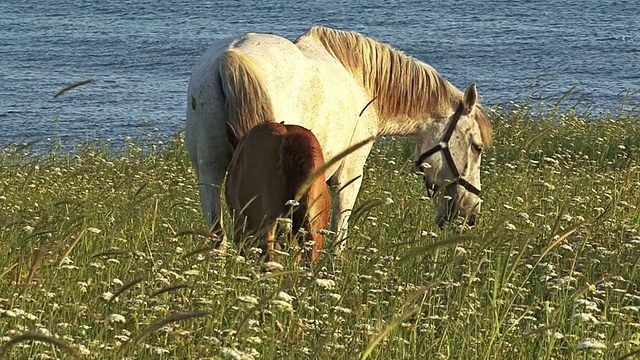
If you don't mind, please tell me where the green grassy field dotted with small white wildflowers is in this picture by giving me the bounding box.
[0,106,640,359]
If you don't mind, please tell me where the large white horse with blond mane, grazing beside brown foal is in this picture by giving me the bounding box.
[186,26,492,243]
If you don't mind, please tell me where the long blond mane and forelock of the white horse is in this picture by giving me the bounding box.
[303,26,491,145]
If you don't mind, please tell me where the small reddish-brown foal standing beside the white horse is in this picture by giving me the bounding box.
[226,122,330,260]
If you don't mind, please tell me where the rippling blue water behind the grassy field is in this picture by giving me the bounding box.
[0,0,640,146]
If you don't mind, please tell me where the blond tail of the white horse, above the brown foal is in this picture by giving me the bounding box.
[218,49,275,138]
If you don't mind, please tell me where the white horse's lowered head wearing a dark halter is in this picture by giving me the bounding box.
[416,84,491,226]
